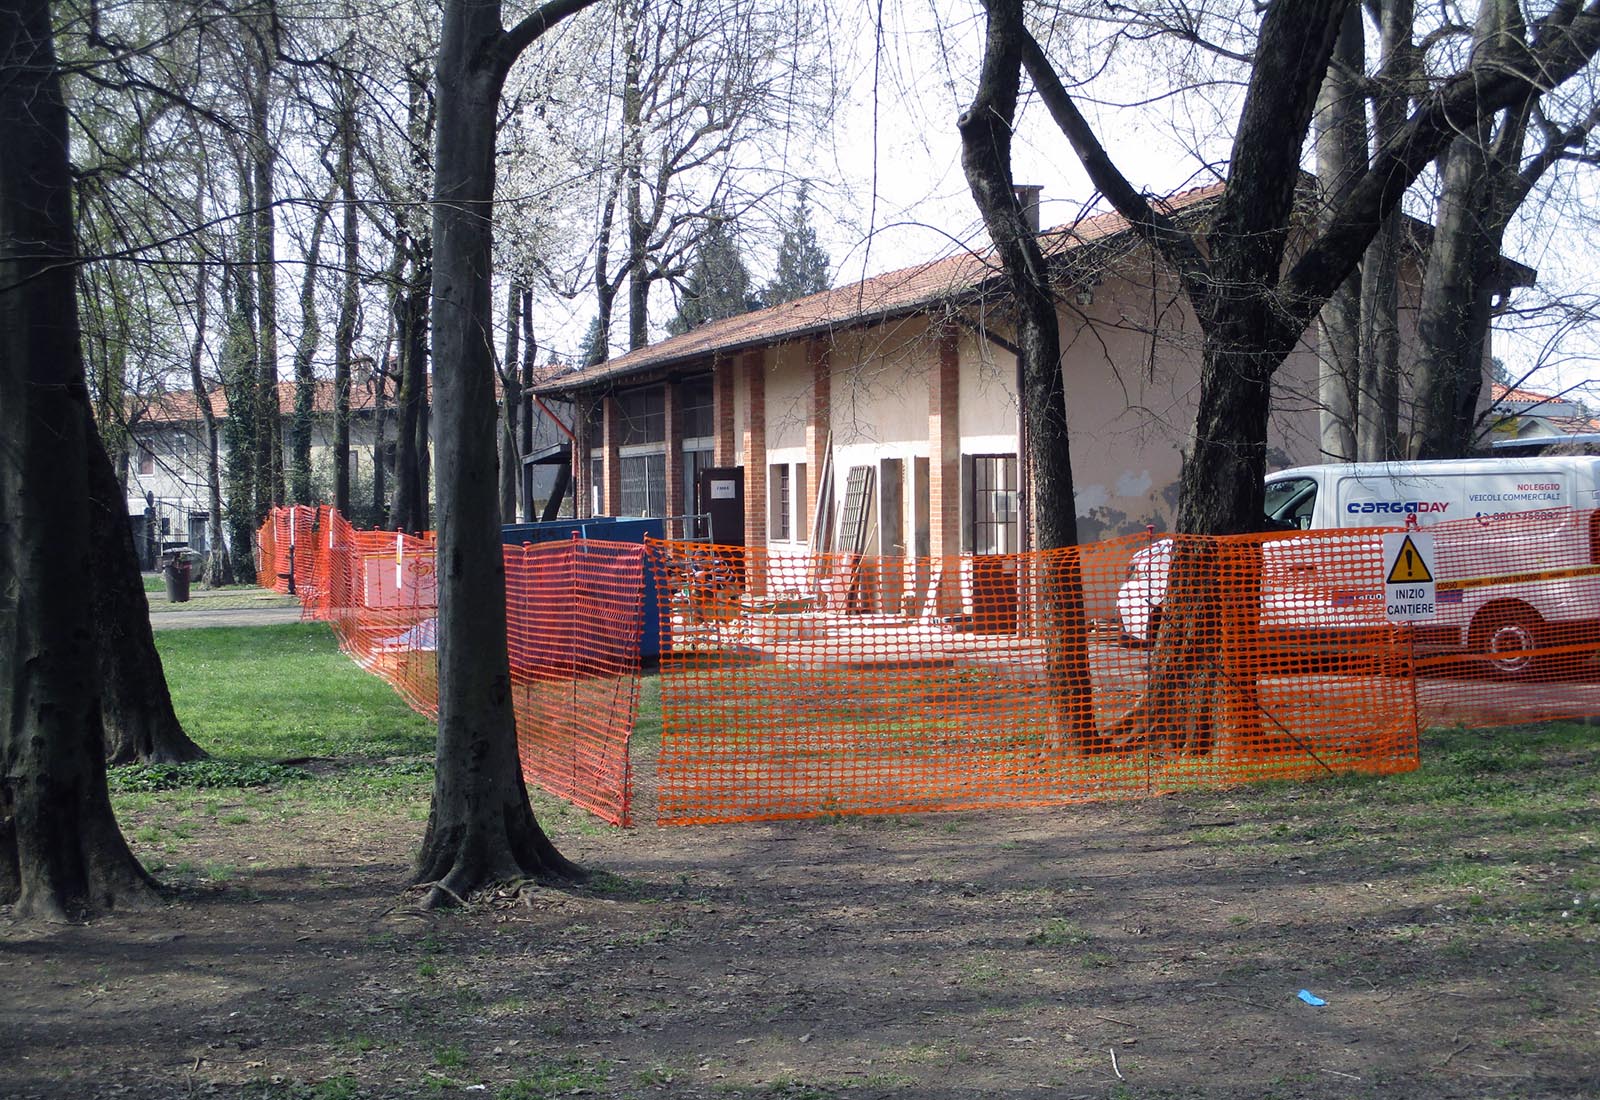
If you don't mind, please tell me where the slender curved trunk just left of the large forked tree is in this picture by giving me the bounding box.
[958,0,1098,751]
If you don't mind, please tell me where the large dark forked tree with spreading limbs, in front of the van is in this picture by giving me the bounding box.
[953,0,1600,751]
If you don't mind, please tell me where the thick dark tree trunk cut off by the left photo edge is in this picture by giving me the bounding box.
[0,0,157,919]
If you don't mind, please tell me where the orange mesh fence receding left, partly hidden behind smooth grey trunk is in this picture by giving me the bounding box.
[258,507,643,825]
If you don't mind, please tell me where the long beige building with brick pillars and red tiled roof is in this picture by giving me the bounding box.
[536,187,1531,575]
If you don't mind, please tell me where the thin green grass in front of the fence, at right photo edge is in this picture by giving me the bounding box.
[1186,721,1600,956]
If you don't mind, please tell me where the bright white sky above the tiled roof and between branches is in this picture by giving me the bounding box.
[508,0,1600,406]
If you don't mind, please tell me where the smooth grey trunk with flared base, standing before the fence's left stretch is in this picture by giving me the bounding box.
[416,0,601,905]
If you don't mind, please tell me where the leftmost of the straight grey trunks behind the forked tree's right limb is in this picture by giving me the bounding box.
[1317,3,1366,462]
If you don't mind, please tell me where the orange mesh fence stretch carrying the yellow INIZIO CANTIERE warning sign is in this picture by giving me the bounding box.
[651,512,1600,823]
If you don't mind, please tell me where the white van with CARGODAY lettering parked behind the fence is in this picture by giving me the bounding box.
[1117,456,1600,675]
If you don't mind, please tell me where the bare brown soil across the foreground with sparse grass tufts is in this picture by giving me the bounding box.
[0,773,1600,1100]
